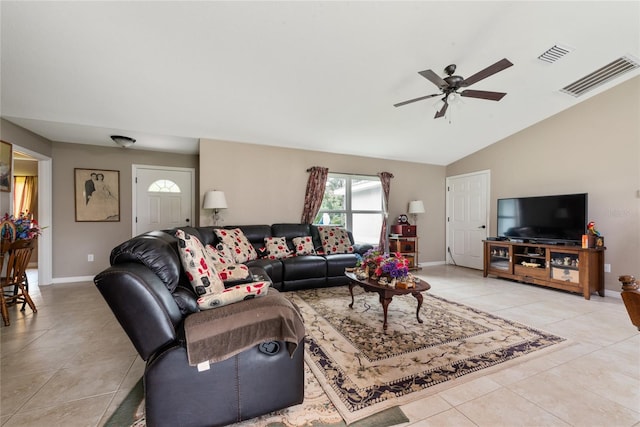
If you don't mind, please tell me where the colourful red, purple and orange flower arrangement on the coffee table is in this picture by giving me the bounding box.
[356,247,413,286]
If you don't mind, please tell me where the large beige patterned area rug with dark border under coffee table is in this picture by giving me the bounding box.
[285,287,565,424]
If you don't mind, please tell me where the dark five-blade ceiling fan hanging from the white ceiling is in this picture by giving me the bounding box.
[393,58,513,119]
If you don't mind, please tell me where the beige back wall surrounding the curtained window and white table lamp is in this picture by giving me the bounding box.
[200,139,445,263]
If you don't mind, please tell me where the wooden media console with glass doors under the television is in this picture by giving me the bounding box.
[483,240,605,299]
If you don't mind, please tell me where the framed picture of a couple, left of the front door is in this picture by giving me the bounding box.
[74,168,120,222]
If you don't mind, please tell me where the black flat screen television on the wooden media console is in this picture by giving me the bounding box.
[498,193,588,244]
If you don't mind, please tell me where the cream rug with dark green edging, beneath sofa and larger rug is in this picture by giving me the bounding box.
[112,363,409,427]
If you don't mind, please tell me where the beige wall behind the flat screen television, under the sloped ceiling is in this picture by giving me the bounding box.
[447,77,640,290]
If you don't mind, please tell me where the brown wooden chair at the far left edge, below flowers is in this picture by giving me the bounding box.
[0,222,38,326]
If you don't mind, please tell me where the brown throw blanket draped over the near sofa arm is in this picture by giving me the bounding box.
[184,288,305,366]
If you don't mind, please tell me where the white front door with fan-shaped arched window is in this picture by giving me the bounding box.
[133,165,195,236]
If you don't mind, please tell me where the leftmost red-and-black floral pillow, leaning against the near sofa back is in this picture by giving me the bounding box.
[176,230,224,296]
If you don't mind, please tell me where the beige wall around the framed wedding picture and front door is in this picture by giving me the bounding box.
[51,142,198,279]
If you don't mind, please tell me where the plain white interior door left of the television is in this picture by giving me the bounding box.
[445,171,490,269]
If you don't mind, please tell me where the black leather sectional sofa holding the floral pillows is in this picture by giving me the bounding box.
[94,224,370,427]
